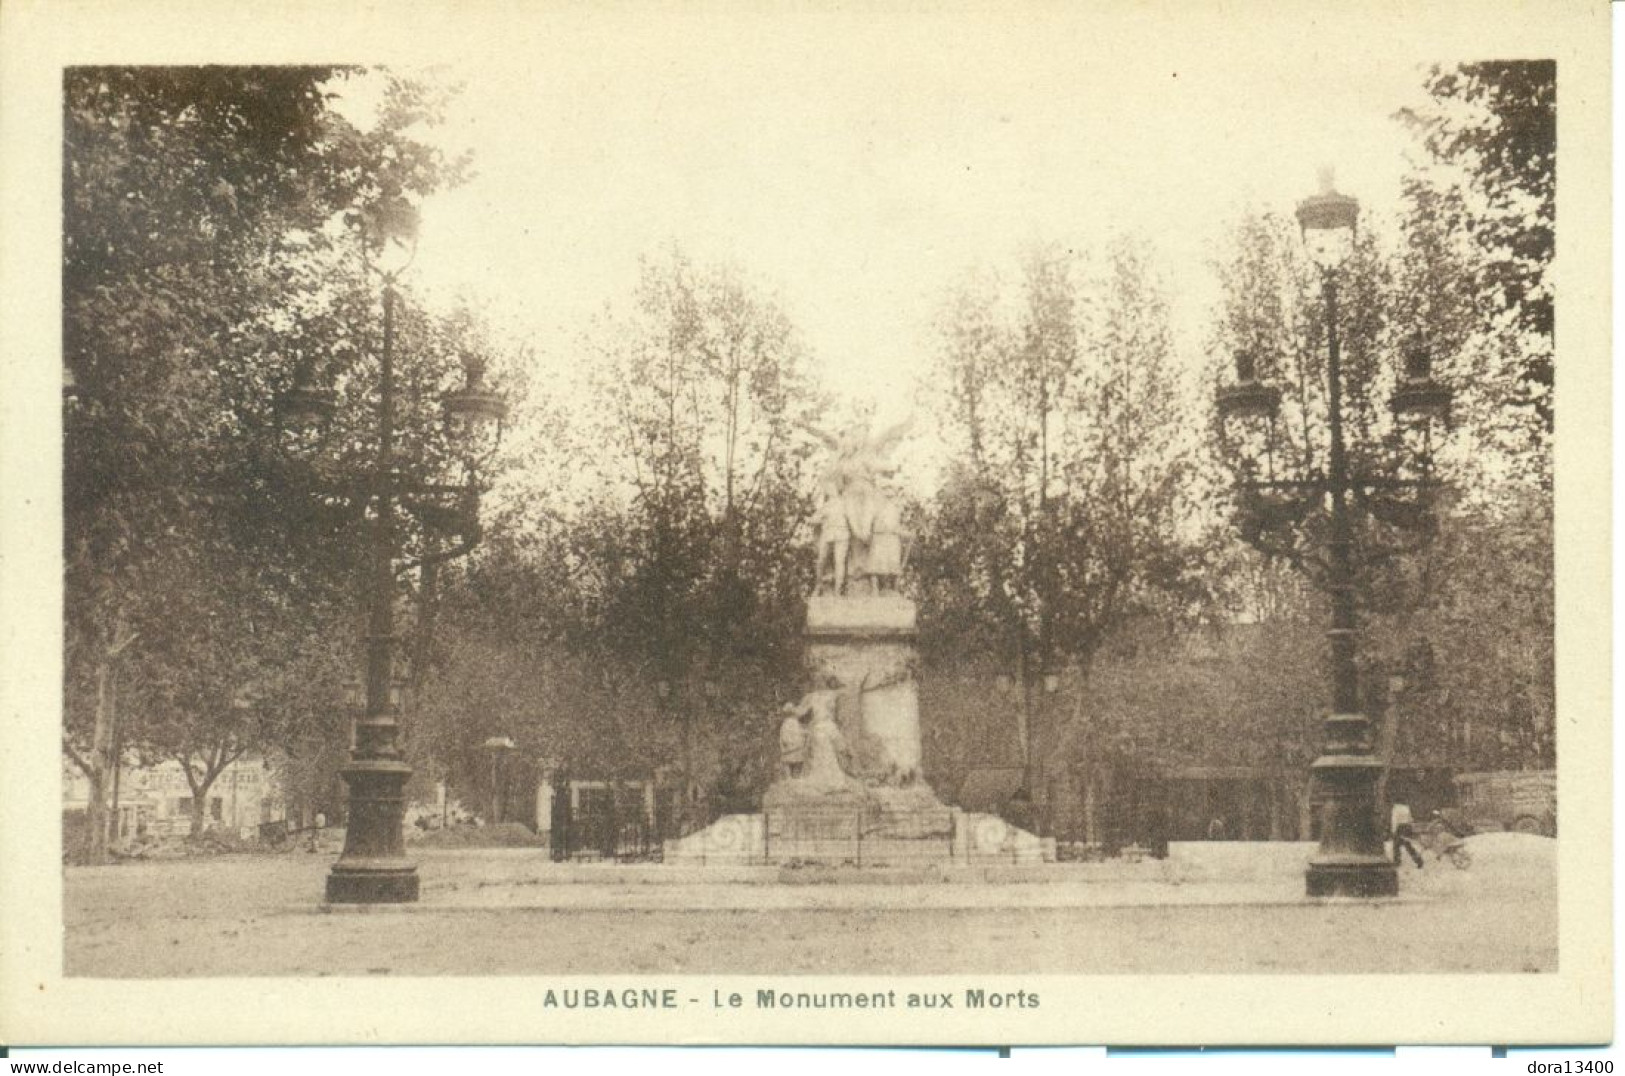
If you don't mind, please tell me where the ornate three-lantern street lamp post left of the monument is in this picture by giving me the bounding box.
[283,229,507,904]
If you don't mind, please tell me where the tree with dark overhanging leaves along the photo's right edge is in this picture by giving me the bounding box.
[1389,60,1558,767]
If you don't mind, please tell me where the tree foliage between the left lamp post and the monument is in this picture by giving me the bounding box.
[406,254,817,809]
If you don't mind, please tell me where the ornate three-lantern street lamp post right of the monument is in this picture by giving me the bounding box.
[1217,172,1450,897]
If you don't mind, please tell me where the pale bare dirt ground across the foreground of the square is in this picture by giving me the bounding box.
[63,834,1557,978]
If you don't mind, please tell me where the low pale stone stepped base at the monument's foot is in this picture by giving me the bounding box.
[663,788,1055,868]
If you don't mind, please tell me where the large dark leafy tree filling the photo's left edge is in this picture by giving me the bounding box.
[63,67,474,857]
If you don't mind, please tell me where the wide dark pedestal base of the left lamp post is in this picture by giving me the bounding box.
[327,759,418,904]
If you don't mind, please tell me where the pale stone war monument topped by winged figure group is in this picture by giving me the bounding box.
[665,421,1055,866]
